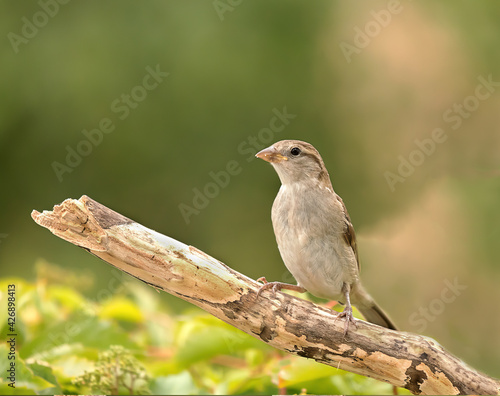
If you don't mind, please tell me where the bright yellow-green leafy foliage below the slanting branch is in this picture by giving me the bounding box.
[0,266,408,395]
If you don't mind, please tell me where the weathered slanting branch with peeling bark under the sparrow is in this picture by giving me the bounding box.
[32,195,500,395]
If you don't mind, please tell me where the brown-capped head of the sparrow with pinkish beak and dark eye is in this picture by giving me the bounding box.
[255,140,331,187]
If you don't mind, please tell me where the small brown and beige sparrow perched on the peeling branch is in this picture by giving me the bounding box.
[256,140,396,336]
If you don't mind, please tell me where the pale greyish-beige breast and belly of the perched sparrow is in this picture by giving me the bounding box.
[272,186,357,299]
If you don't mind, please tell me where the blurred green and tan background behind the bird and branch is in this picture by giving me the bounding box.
[0,0,500,377]
